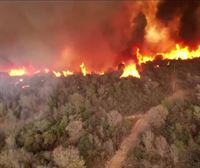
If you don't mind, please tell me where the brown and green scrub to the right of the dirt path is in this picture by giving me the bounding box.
[124,82,200,168]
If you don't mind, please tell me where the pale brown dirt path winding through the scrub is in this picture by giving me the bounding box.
[105,90,187,168]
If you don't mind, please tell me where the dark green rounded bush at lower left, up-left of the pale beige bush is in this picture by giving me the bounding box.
[15,120,59,153]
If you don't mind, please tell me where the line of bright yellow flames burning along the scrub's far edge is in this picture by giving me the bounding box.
[3,44,200,78]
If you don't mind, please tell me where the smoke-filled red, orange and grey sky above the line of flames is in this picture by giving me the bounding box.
[0,0,200,69]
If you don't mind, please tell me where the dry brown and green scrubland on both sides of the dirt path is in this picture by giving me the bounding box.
[0,59,200,168]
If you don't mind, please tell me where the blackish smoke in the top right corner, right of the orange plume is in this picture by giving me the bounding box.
[156,0,200,45]
